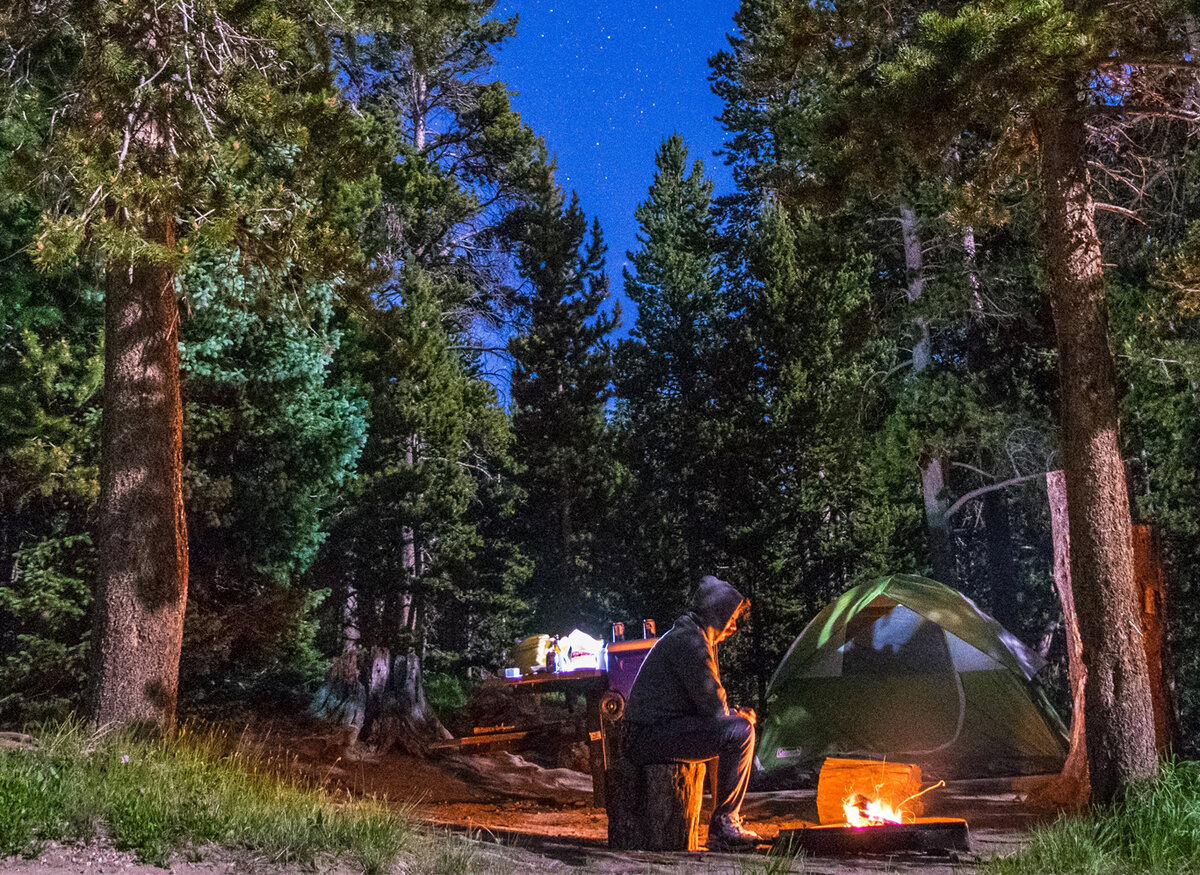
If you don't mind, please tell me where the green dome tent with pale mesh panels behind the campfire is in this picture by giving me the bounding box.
[757,574,1068,778]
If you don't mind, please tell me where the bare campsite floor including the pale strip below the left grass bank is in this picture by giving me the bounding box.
[0,721,1055,875]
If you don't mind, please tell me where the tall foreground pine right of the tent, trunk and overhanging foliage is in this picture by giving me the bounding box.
[715,0,1193,802]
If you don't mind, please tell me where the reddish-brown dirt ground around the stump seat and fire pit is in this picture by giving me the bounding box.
[274,715,1056,875]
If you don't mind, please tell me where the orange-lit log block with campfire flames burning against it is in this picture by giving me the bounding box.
[817,756,924,826]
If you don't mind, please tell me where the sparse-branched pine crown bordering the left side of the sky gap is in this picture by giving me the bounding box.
[338,0,545,321]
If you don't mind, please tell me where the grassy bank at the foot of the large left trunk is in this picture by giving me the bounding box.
[0,724,413,875]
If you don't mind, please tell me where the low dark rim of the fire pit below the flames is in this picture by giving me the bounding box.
[775,817,971,856]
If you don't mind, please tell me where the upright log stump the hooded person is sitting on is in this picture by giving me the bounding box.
[604,723,704,851]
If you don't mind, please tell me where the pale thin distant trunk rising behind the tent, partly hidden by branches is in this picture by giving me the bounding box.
[900,204,958,586]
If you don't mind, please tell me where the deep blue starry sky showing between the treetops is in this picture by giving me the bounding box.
[496,0,738,334]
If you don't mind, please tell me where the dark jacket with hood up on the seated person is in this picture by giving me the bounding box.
[625,576,745,724]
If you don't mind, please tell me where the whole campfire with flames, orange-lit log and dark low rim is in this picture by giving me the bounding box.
[775,757,971,855]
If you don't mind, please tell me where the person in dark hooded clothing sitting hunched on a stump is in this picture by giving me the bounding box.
[625,568,760,850]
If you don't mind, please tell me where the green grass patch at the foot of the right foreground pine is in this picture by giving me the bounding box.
[988,761,1200,875]
